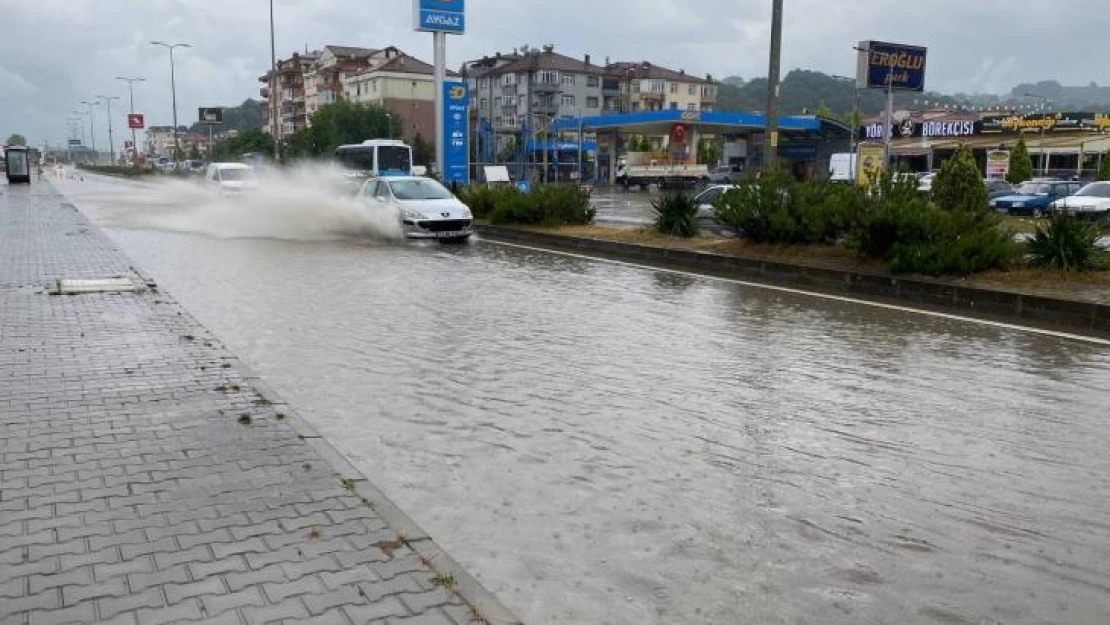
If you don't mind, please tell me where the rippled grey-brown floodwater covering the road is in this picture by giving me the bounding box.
[58,170,1110,625]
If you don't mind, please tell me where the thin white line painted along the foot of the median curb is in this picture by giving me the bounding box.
[482,238,1110,346]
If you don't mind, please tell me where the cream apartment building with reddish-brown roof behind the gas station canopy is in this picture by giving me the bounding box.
[604,61,717,113]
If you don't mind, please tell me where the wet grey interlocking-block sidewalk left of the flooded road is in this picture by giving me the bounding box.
[0,185,514,625]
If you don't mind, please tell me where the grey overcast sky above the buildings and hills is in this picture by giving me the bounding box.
[0,0,1110,148]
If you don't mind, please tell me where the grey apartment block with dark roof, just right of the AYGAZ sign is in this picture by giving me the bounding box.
[464,46,605,139]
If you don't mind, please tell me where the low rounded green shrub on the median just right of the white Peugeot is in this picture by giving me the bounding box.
[486,184,595,228]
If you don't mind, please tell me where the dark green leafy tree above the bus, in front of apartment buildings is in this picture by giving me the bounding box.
[290,100,390,158]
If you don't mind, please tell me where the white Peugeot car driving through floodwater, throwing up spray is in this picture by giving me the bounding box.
[359,175,474,242]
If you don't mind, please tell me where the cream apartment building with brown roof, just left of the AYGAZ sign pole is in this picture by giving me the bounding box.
[343,47,458,143]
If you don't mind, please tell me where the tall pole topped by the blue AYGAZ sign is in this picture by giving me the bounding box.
[413,0,470,175]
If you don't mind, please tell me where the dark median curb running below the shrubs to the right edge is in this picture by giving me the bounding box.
[475,225,1110,339]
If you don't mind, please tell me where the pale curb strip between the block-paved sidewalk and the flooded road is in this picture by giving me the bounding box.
[54,188,523,625]
